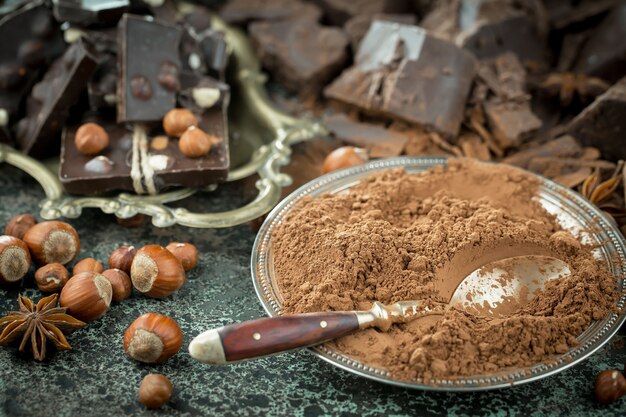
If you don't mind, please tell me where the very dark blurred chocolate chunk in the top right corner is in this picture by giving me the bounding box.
[574,2,626,83]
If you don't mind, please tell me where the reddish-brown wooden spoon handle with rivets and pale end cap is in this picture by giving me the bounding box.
[189,311,359,365]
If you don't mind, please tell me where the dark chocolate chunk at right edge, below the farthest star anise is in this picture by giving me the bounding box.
[567,77,626,160]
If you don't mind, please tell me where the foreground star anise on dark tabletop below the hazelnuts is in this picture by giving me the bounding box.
[0,294,86,361]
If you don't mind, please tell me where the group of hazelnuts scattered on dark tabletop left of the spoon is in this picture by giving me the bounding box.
[0,214,198,408]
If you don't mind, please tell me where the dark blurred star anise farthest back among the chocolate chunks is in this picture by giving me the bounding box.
[541,72,609,106]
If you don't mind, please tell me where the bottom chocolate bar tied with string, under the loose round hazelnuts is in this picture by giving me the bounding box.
[59,73,230,195]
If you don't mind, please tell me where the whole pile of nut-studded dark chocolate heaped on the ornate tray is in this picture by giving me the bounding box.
[0,0,230,195]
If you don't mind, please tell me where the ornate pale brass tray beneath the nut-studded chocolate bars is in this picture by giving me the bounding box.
[0,17,326,228]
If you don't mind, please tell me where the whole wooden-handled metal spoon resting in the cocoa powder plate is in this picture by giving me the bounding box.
[189,256,570,365]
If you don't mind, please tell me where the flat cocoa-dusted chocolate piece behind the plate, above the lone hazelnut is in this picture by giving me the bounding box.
[324,114,408,158]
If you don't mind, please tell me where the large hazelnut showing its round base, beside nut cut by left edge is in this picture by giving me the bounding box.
[24,221,80,265]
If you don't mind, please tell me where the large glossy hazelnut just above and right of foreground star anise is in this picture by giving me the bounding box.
[59,272,113,321]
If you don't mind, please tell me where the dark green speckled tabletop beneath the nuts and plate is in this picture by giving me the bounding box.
[0,165,626,416]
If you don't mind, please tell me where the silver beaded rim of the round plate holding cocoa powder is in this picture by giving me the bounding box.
[251,157,626,391]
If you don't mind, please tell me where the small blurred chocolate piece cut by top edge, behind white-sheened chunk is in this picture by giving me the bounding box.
[315,0,410,26]
